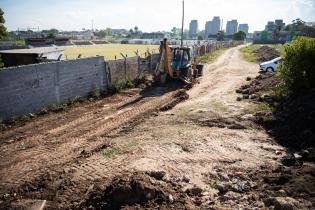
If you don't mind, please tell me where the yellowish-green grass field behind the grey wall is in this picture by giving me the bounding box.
[65,44,159,60]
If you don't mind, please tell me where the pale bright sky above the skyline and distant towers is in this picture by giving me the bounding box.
[0,0,315,32]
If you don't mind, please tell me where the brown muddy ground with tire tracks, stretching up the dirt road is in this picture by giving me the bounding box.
[0,47,314,209]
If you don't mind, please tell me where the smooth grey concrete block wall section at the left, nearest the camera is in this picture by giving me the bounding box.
[0,56,108,119]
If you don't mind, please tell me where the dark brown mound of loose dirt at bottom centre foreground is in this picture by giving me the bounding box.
[75,172,194,210]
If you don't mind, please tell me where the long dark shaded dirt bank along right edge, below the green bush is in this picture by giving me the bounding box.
[237,73,315,209]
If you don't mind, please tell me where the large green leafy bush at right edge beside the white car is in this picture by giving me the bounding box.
[278,37,315,95]
